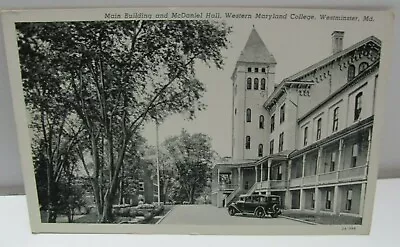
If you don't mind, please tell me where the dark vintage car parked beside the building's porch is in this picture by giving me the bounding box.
[228,195,282,218]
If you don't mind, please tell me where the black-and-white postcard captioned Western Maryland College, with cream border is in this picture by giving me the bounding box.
[1,7,394,235]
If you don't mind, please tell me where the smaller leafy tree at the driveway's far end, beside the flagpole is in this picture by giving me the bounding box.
[163,130,216,203]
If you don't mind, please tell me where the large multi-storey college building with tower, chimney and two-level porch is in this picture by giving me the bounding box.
[212,29,381,217]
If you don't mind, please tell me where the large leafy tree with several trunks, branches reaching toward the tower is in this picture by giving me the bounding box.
[17,20,230,222]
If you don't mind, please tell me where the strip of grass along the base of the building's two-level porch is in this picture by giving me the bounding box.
[283,211,362,225]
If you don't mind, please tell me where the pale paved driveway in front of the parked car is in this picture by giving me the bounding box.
[160,205,304,225]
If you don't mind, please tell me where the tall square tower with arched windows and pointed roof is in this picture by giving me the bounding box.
[231,27,276,160]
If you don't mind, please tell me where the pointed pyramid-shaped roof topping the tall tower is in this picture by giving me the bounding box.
[238,27,276,63]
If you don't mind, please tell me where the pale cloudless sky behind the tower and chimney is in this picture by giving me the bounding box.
[143,14,384,157]
